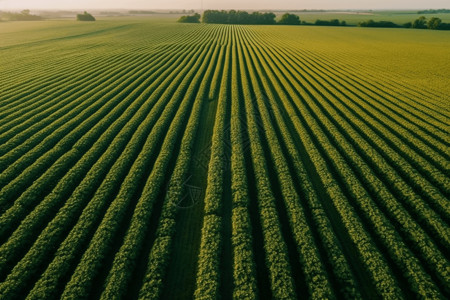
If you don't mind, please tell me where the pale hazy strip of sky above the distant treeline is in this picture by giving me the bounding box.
[0,0,450,10]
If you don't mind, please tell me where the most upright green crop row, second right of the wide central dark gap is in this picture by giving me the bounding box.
[230,41,258,299]
